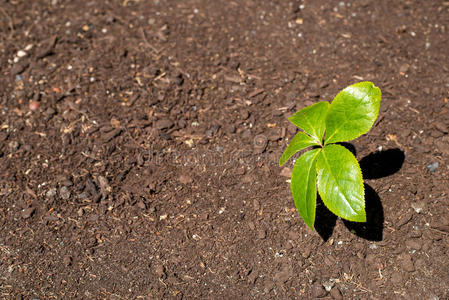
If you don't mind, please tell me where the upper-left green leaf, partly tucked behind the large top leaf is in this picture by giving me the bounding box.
[289,101,329,145]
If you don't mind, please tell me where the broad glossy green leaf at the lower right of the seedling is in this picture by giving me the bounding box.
[316,145,366,222]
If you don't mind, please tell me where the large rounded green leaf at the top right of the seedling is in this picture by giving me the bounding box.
[325,81,381,145]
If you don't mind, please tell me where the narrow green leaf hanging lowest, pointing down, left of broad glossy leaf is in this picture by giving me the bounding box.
[290,149,321,230]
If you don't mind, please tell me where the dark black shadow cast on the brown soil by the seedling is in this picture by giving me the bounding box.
[315,148,405,241]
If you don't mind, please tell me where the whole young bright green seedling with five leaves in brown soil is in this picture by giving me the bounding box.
[279,82,381,230]
